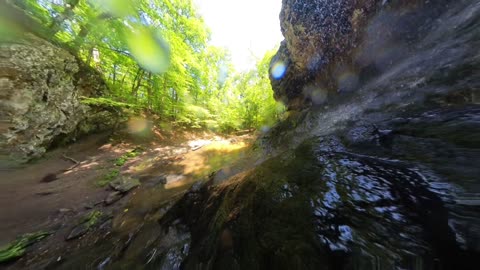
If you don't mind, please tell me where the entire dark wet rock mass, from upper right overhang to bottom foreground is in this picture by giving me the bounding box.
[148,1,480,269]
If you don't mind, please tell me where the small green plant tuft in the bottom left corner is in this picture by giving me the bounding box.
[0,231,51,263]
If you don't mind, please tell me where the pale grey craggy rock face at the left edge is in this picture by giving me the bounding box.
[0,34,106,161]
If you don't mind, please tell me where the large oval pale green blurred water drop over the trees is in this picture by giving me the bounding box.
[127,29,170,74]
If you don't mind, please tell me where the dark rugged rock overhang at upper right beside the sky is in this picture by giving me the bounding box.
[270,0,448,109]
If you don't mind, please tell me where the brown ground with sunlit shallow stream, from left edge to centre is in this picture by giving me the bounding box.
[0,127,254,268]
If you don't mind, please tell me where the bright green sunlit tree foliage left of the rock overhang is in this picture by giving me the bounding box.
[4,0,285,132]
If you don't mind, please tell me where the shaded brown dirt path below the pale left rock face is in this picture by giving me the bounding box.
[0,135,114,246]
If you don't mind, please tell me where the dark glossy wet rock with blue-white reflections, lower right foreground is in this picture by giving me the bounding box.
[156,133,480,269]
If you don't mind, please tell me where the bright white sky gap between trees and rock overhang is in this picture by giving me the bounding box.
[194,0,283,70]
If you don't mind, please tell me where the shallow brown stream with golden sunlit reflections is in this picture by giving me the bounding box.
[113,137,251,236]
